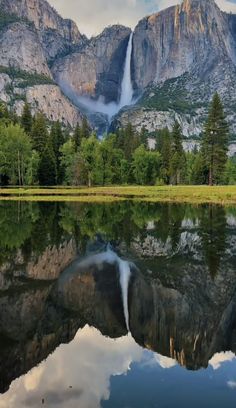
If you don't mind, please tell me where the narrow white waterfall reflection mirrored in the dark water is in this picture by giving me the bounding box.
[119,258,131,331]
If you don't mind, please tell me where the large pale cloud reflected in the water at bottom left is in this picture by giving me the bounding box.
[0,326,143,408]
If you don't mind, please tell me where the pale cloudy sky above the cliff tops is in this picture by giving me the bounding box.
[48,0,236,37]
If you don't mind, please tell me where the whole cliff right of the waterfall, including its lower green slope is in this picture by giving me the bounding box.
[115,0,236,136]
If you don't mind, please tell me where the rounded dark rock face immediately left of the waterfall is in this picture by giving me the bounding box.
[52,26,131,103]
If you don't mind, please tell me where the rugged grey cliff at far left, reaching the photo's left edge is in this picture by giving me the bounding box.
[0,0,86,126]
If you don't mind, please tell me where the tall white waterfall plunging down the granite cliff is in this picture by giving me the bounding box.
[119,32,134,109]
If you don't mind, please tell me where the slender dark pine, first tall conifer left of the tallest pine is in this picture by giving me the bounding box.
[170,121,185,185]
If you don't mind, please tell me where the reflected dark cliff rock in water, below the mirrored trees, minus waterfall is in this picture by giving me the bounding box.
[0,247,236,392]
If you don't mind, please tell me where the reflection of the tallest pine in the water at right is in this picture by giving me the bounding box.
[200,204,227,277]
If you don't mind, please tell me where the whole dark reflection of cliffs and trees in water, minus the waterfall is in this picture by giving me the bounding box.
[0,203,236,392]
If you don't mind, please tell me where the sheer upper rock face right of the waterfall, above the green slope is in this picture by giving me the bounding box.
[133,0,236,89]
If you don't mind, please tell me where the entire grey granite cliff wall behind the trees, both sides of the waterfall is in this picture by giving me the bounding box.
[0,0,236,137]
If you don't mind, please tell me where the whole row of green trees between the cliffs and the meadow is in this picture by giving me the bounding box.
[0,94,236,187]
